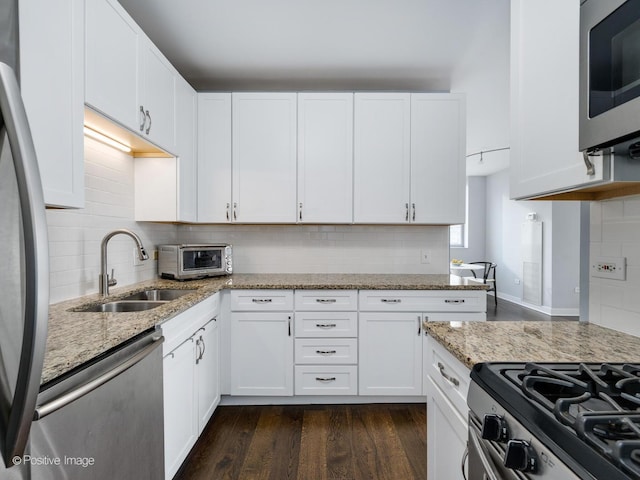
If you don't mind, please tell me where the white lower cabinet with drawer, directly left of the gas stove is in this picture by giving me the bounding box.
[424,336,470,480]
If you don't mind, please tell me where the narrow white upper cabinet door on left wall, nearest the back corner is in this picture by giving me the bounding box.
[176,78,198,222]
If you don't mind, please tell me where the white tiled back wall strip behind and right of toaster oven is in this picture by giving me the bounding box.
[178,225,449,273]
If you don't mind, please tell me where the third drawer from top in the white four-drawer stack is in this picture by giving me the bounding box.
[295,338,358,365]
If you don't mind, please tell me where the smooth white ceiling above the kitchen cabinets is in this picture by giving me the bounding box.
[120,0,509,174]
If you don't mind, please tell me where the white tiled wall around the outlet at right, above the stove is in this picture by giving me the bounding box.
[588,196,640,336]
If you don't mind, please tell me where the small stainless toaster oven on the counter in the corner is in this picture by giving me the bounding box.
[158,244,233,280]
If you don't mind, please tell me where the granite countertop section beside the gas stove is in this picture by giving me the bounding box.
[424,321,640,368]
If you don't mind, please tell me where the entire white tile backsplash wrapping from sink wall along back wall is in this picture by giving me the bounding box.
[47,139,449,303]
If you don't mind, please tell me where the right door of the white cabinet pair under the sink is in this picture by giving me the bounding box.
[195,318,220,432]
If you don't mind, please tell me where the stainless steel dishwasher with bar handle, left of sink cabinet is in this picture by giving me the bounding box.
[22,330,164,480]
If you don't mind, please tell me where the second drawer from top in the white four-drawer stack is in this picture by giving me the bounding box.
[295,312,358,338]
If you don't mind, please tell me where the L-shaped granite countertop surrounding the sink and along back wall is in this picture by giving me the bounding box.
[42,274,486,384]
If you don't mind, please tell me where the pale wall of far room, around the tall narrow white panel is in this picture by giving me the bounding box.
[486,170,580,315]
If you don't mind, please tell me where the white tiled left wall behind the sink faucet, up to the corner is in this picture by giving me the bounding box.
[47,139,176,303]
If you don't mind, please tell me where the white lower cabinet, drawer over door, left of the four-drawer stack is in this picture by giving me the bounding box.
[230,290,293,396]
